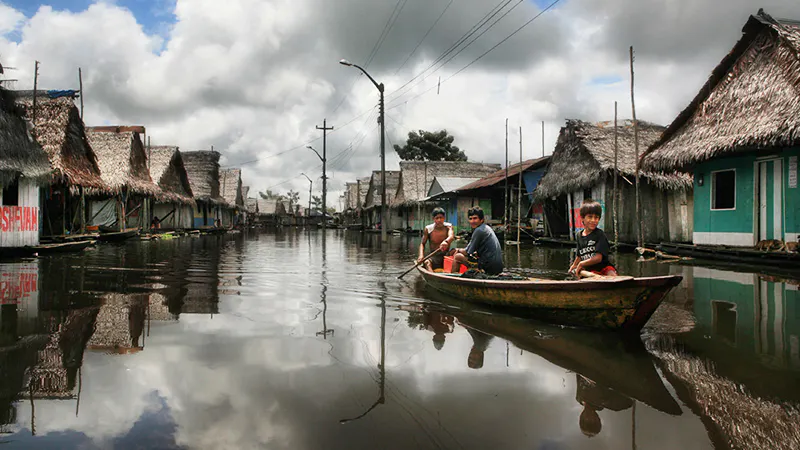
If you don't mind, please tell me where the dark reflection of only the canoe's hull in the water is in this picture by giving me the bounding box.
[442,299,682,415]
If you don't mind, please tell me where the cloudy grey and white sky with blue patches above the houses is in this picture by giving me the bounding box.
[0,0,800,208]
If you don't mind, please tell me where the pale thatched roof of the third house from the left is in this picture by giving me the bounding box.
[86,127,161,196]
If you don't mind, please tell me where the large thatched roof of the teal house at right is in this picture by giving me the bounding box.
[643,10,800,170]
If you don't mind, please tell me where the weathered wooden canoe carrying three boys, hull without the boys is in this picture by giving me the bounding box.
[417,267,683,331]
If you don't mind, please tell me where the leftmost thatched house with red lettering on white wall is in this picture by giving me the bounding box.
[0,88,52,246]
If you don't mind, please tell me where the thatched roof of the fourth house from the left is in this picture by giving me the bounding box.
[148,145,194,205]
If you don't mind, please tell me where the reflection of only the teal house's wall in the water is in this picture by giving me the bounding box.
[694,267,800,370]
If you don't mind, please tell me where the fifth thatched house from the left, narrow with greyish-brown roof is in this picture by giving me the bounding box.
[181,150,224,229]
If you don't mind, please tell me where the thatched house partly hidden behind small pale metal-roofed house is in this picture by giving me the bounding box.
[390,161,500,231]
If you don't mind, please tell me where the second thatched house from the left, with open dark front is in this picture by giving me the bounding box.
[18,91,112,237]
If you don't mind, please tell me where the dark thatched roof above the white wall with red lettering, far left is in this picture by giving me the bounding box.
[0,87,53,186]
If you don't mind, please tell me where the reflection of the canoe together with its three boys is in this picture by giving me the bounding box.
[400,282,682,436]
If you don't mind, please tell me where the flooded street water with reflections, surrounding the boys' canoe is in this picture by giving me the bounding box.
[0,229,800,450]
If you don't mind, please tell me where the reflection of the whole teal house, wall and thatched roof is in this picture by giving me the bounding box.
[645,267,800,448]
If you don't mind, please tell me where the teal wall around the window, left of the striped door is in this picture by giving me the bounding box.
[694,155,756,233]
